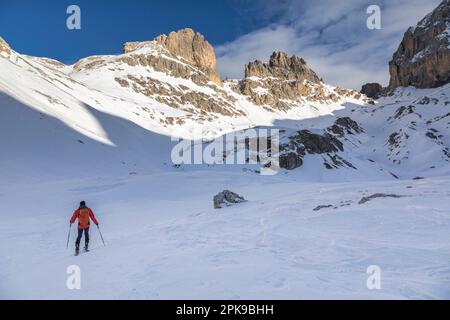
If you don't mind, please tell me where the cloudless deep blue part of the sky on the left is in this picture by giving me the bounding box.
[0,0,250,62]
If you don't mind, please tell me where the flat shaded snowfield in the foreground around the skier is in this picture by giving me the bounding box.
[0,172,450,299]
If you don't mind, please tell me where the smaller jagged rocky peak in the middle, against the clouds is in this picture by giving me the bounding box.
[245,51,320,83]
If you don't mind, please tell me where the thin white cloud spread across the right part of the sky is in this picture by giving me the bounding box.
[216,0,440,89]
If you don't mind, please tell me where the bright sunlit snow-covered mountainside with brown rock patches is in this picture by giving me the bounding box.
[0,35,370,139]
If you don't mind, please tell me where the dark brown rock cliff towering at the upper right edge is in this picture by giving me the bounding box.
[388,0,450,91]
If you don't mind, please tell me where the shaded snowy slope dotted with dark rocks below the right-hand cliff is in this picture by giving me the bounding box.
[275,85,450,179]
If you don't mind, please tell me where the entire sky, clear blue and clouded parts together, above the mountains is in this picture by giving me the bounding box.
[0,0,440,89]
